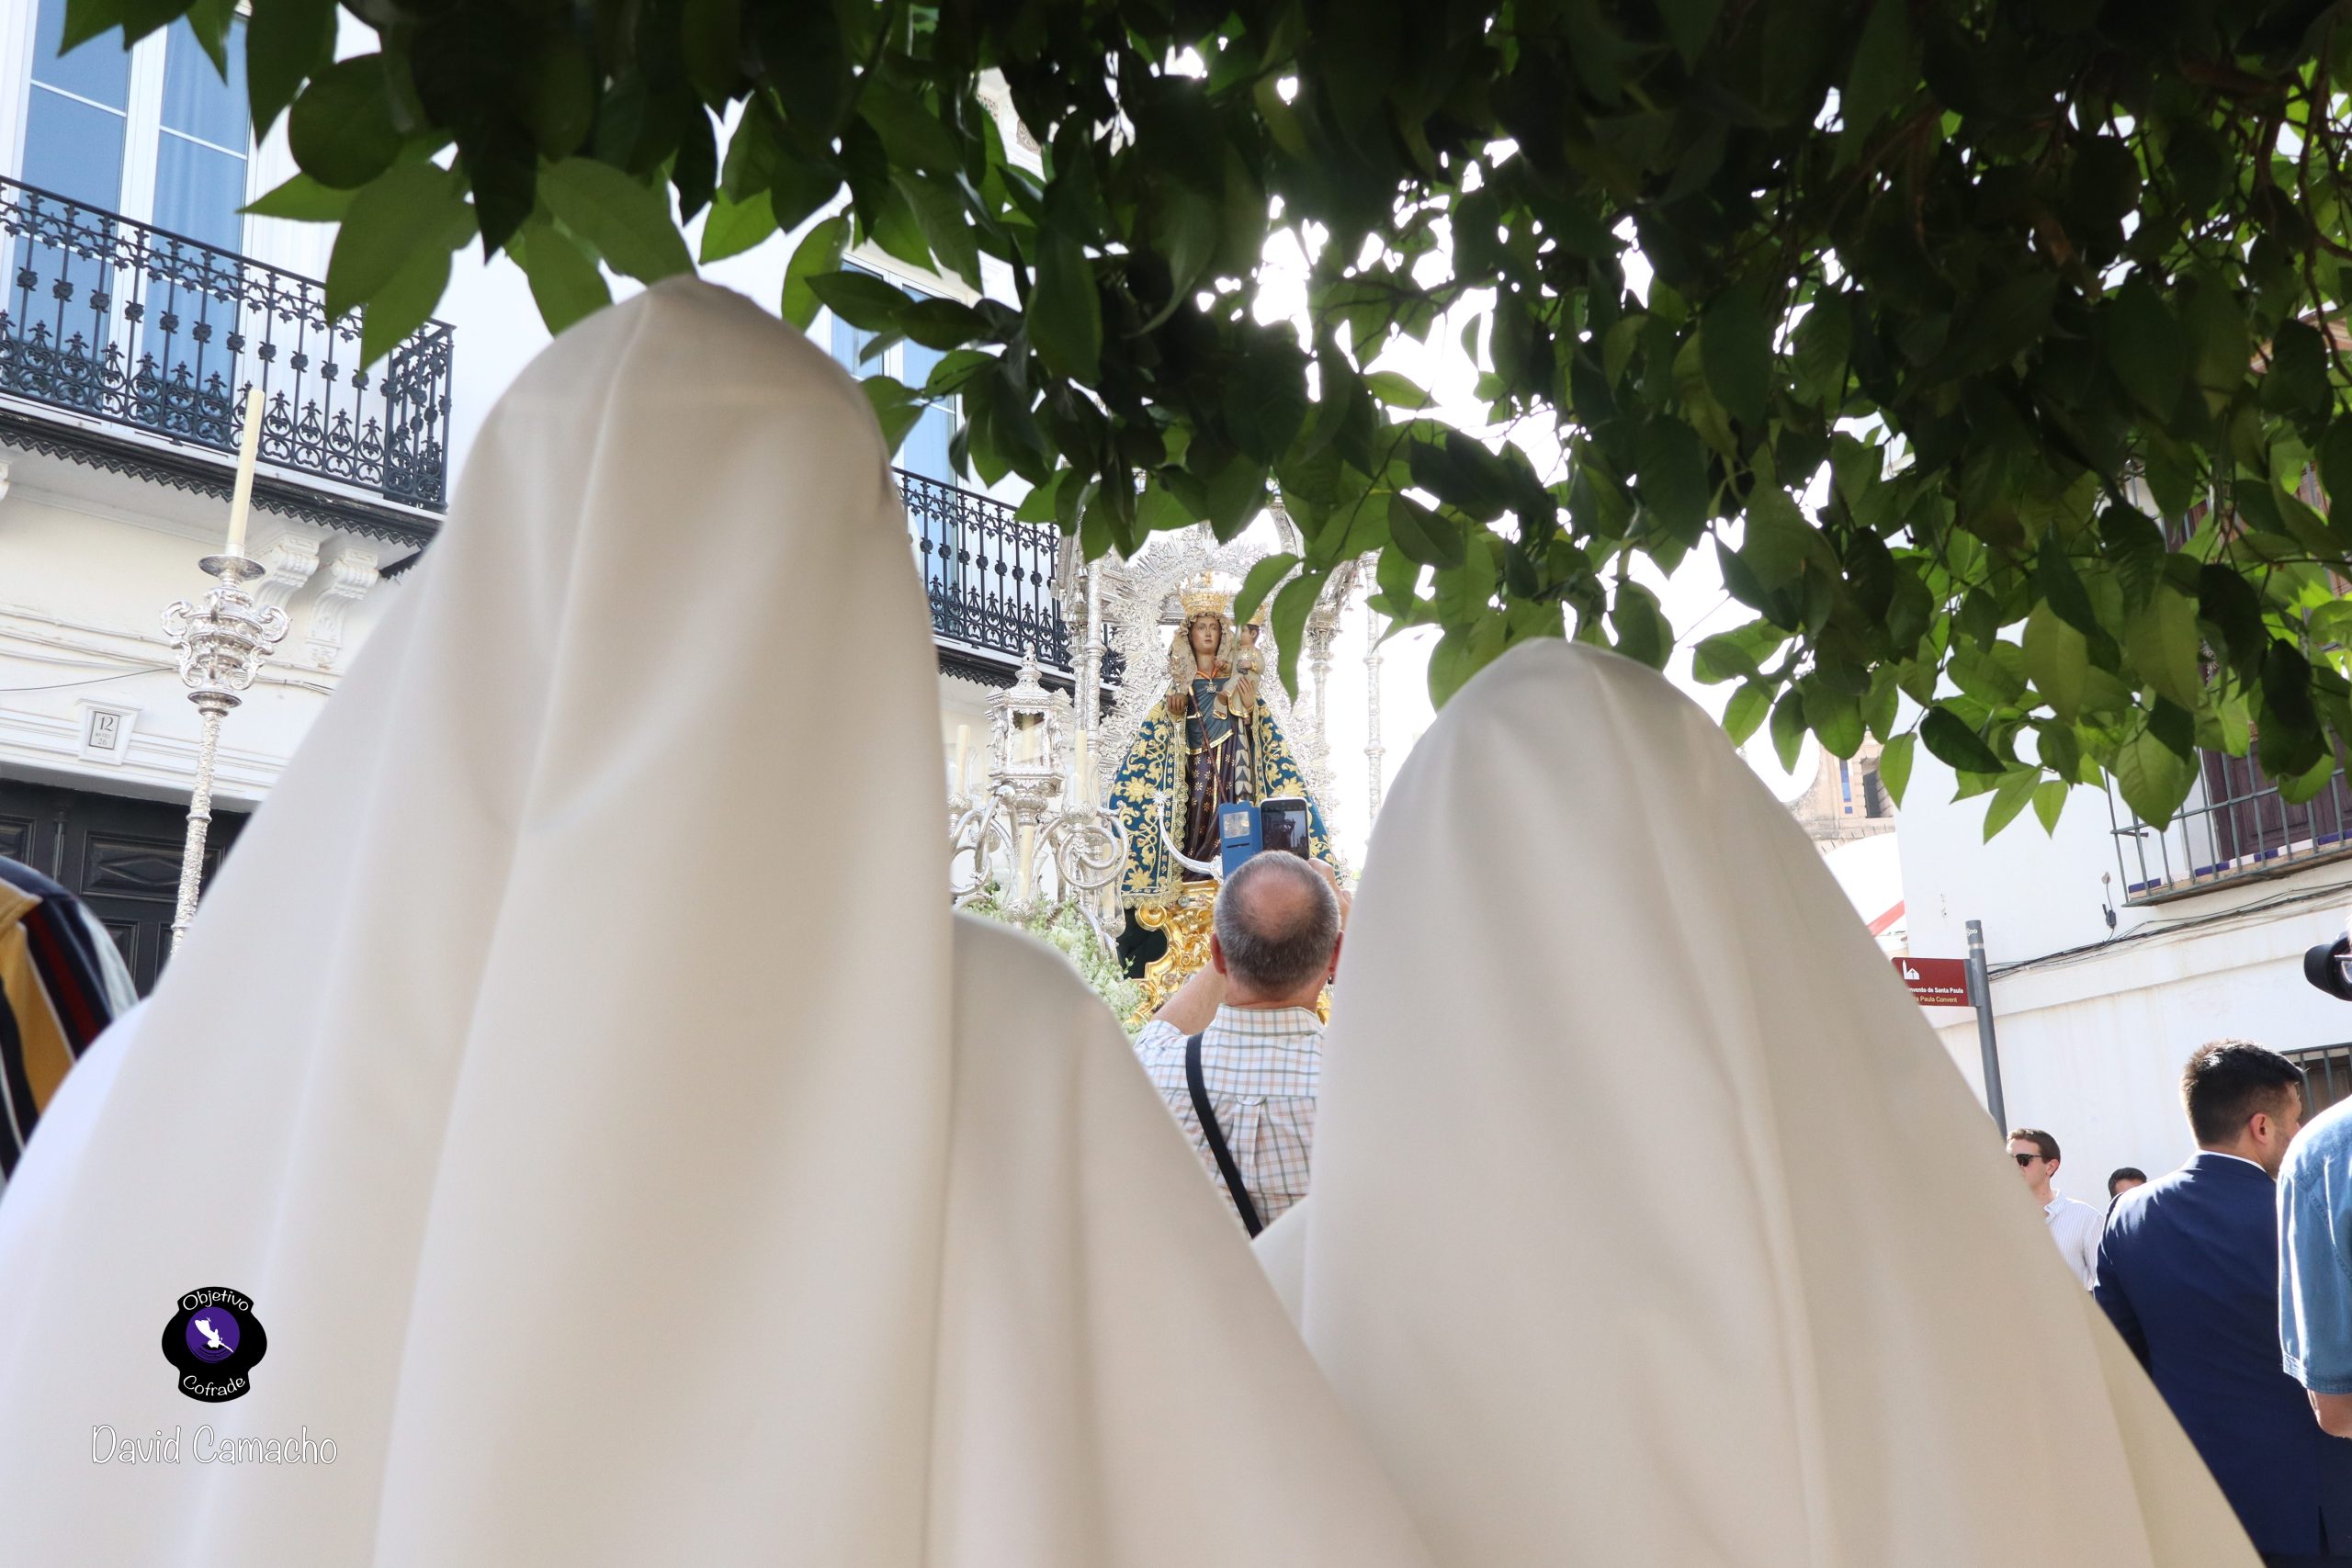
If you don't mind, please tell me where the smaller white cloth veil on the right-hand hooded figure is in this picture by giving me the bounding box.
[1261,642,2253,1568]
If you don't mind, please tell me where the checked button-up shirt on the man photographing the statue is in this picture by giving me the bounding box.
[1136,1006,1322,1224]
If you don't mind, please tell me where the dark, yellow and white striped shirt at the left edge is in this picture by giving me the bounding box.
[0,861,136,1178]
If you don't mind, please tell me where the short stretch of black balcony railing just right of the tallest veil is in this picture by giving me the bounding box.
[899,468,1070,672]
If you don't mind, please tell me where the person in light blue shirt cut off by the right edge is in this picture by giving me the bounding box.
[2279,1100,2352,1437]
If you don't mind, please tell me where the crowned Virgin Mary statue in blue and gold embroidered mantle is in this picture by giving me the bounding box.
[1110,585,1331,903]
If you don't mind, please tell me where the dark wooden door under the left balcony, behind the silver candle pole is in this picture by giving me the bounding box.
[0,778,244,997]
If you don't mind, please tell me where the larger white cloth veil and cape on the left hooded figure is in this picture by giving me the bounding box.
[0,282,1419,1568]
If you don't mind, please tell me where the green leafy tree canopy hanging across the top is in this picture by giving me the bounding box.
[68,0,2352,832]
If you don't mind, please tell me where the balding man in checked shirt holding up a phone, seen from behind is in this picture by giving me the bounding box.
[1136,853,1345,1236]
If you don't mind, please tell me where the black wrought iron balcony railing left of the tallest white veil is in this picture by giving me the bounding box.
[0,179,452,510]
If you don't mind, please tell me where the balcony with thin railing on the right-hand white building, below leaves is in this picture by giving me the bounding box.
[2108,752,2352,903]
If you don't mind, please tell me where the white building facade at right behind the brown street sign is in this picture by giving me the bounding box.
[1895,752,2352,1201]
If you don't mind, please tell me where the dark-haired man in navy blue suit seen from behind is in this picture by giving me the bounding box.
[2098,1039,2352,1568]
